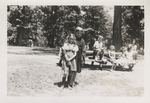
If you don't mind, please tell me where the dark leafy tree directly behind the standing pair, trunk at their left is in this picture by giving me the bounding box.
[41,6,80,47]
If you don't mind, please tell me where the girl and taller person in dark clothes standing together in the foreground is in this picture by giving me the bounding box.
[62,27,85,87]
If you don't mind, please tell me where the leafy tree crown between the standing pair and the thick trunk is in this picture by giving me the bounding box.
[82,6,112,41]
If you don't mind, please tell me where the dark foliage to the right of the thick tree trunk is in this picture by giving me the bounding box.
[122,6,144,47]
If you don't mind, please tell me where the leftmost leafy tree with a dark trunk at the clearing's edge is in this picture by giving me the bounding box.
[8,5,31,45]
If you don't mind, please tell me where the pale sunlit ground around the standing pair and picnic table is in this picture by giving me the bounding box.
[7,46,144,97]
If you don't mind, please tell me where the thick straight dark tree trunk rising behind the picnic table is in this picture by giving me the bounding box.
[113,6,122,51]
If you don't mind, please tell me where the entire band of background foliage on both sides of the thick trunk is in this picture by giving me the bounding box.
[7,5,144,47]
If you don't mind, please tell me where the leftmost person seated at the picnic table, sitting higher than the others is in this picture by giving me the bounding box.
[93,35,104,61]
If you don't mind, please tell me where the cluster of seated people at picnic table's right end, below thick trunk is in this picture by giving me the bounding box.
[108,44,137,71]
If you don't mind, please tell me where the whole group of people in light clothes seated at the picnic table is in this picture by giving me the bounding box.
[93,36,137,71]
